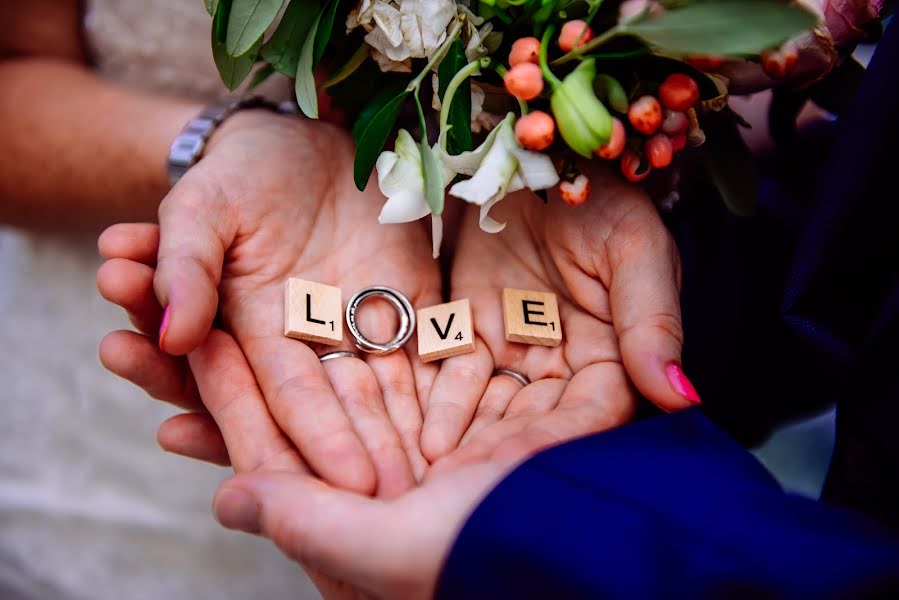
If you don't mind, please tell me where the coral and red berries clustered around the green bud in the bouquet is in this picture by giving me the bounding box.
[503,20,699,205]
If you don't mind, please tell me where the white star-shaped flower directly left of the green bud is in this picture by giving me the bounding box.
[435,113,559,233]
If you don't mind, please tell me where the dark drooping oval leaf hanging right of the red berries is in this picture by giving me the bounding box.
[701,112,759,217]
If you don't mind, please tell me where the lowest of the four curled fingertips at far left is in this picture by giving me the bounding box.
[156,413,231,467]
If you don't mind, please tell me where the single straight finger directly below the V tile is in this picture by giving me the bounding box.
[421,340,493,462]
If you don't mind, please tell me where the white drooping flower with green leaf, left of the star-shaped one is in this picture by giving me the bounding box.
[375,129,454,258]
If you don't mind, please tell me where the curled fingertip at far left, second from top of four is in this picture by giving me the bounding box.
[97,258,162,337]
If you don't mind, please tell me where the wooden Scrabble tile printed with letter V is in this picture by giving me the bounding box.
[418,299,474,362]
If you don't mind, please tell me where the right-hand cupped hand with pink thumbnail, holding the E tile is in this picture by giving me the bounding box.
[422,163,698,465]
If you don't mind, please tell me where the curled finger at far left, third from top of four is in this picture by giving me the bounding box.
[100,331,205,411]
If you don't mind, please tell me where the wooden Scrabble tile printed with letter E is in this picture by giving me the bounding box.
[503,288,562,346]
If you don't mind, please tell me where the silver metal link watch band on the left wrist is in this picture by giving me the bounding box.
[166,96,278,185]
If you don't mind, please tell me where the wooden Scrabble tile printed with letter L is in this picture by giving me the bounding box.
[284,279,343,346]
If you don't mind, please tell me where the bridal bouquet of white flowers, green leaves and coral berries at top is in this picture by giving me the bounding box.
[206,0,879,256]
